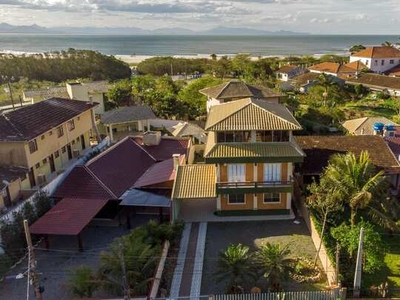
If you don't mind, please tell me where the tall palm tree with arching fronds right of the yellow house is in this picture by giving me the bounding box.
[325,151,397,229]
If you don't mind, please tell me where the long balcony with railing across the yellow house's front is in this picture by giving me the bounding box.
[217,180,293,194]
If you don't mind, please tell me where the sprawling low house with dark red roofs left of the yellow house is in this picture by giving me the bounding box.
[30,137,190,249]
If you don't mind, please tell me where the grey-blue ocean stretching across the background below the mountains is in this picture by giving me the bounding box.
[0,34,399,56]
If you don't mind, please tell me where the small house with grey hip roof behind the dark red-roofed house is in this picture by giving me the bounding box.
[101,105,156,142]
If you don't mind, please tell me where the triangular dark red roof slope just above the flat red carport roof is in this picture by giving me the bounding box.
[52,166,118,200]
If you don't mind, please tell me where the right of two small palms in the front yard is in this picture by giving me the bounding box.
[256,243,292,291]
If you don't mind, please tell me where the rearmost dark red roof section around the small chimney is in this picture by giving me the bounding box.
[131,136,190,161]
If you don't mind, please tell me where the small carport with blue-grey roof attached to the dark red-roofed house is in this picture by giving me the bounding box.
[119,188,171,228]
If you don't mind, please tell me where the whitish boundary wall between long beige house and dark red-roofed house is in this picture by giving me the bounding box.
[0,137,110,222]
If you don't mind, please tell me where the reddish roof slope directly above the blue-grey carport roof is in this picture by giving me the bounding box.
[133,155,185,188]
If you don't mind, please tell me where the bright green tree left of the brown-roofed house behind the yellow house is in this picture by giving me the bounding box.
[178,77,222,120]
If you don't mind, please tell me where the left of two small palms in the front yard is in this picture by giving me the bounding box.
[216,244,256,291]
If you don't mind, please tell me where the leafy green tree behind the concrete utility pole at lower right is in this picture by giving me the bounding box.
[331,221,386,273]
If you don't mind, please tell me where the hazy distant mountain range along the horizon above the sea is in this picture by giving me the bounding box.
[0,23,308,36]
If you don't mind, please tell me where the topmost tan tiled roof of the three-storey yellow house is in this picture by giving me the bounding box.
[205,98,301,131]
